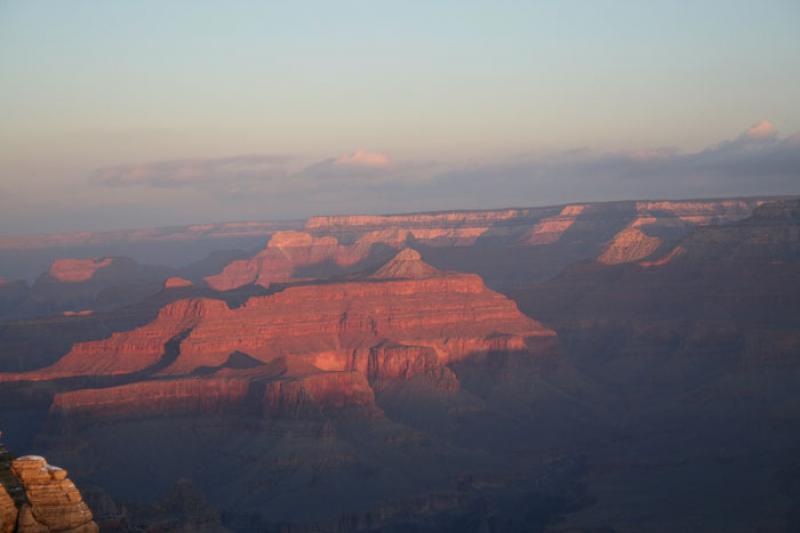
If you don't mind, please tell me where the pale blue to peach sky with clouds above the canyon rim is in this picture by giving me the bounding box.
[0,0,800,234]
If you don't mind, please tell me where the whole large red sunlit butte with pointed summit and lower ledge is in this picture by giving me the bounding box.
[0,249,556,420]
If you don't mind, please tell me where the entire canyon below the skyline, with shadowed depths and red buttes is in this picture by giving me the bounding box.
[0,198,800,532]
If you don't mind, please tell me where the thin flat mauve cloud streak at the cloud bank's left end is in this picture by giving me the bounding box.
[91,154,290,187]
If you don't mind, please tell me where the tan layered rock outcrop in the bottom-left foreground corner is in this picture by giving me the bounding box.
[0,447,99,533]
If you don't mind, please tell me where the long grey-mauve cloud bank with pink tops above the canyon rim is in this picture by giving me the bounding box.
[91,120,800,218]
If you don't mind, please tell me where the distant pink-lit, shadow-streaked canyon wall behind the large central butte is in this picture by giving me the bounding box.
[206,199,762,290]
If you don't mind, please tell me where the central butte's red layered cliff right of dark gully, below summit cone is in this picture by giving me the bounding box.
[170,268,554,374]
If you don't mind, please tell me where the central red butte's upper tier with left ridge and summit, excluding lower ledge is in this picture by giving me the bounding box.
[0,252,555,381]
